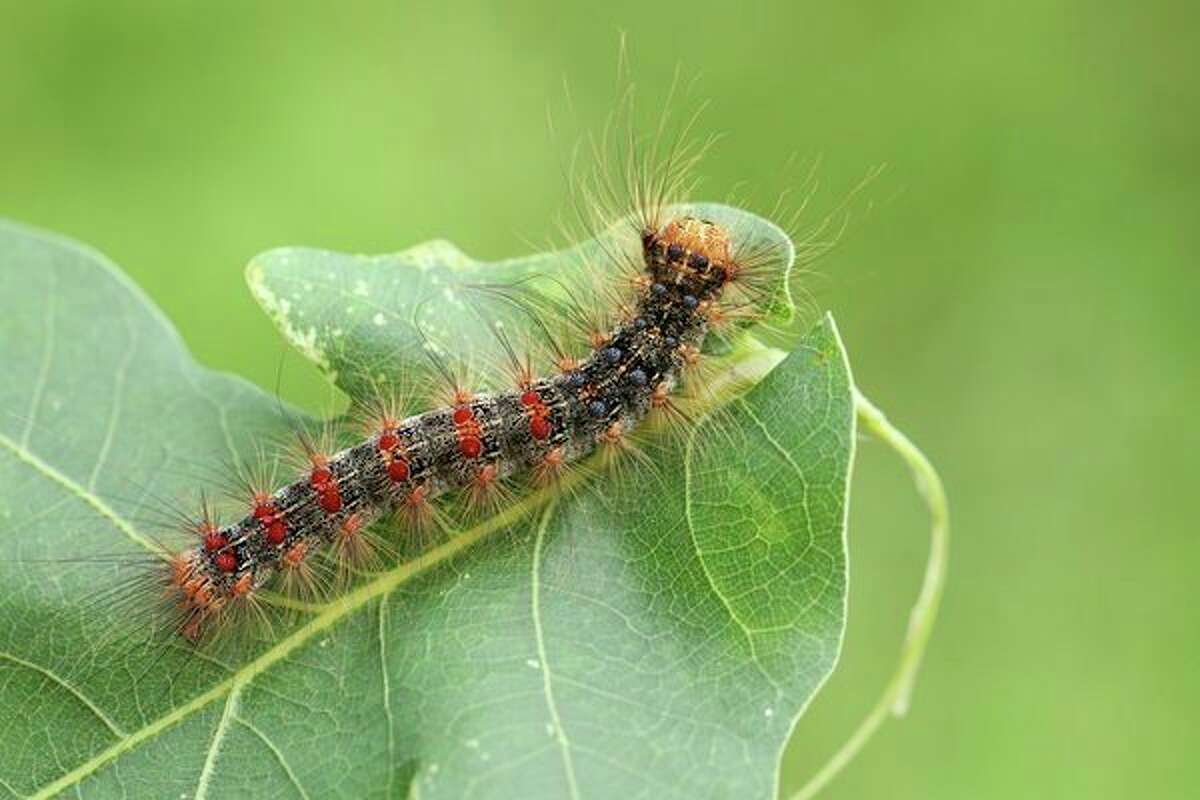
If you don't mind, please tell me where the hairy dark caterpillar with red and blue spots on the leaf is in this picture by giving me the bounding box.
[166,217,739,640]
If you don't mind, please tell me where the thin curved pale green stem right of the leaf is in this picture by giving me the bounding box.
[792,389,950,800]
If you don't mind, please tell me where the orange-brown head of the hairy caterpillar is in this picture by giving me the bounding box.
[642,216,734,297]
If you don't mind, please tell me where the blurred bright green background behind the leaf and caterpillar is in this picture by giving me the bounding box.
[0,0,1200,798]
